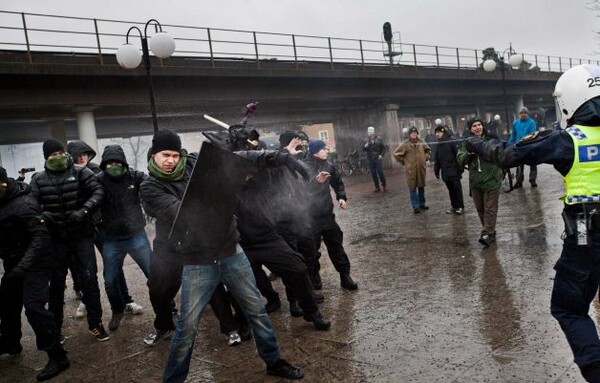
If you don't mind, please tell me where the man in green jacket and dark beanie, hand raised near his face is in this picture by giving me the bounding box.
[456,117,502,247]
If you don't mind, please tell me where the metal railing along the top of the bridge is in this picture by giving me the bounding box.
[0,11,600,72]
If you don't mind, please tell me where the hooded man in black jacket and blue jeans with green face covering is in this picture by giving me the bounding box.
[98,145,152,331]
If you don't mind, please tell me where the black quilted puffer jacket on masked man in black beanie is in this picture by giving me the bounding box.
[31,160,104,238]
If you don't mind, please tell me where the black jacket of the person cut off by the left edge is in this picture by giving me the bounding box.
[0,178,53,272]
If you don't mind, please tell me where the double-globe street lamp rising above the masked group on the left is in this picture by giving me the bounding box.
[117,19,175,132]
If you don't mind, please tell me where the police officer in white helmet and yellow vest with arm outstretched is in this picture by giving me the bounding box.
[467,65,600,382]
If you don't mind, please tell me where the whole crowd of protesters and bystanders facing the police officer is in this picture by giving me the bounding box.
[0,100,580,382]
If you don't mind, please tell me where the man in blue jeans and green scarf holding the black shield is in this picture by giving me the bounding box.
[141,130,304,382]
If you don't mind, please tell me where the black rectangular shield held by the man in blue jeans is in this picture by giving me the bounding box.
[169,142,252,240]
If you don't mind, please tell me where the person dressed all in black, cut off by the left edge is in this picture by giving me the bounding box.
[0,167,69,381]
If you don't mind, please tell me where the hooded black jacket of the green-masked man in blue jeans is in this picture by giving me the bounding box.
[98,145,148,237]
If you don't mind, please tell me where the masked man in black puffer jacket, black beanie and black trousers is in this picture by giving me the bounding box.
[31,139,110,342]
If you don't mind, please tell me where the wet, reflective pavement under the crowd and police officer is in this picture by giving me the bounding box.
[0,165,599,383]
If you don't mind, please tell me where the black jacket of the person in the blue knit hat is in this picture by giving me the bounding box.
[305,157,347,218]
